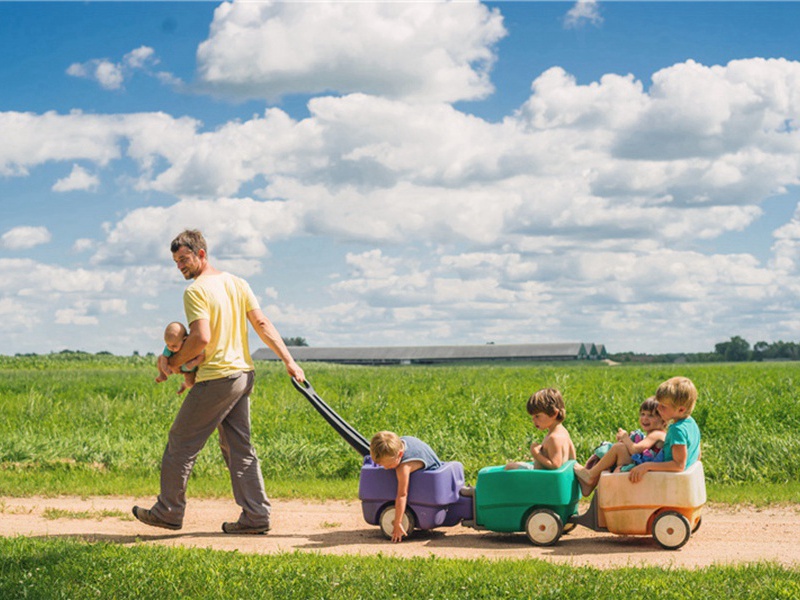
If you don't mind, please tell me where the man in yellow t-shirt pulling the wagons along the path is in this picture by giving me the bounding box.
[133,230,305,533]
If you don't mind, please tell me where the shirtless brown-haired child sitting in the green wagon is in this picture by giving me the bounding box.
[506,388,575,469]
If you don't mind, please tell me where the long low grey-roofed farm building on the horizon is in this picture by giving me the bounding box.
[253,342,608,365]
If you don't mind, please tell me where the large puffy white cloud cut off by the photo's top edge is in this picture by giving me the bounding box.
[197,2,506,101]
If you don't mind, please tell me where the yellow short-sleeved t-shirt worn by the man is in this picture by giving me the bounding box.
[183,273,260,382]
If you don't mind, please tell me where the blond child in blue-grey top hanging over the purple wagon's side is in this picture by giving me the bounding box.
[369,431,442,542]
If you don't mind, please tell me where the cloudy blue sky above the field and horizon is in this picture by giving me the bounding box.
[0,1,800,355]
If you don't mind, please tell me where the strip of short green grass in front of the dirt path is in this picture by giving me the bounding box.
[0,538,800,600]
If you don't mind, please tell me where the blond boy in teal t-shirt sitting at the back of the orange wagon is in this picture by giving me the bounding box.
[575,377,700,495]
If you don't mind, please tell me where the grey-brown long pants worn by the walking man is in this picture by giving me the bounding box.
[151,371,270,527]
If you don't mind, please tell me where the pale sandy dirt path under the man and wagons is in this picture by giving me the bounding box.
[0,497,800,568]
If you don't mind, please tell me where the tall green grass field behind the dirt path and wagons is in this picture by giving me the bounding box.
[0,355,800,503]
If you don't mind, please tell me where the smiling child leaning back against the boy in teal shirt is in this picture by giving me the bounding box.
[575,396,666,496]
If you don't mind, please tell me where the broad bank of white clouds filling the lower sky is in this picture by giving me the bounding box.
[0,51,800,351]
